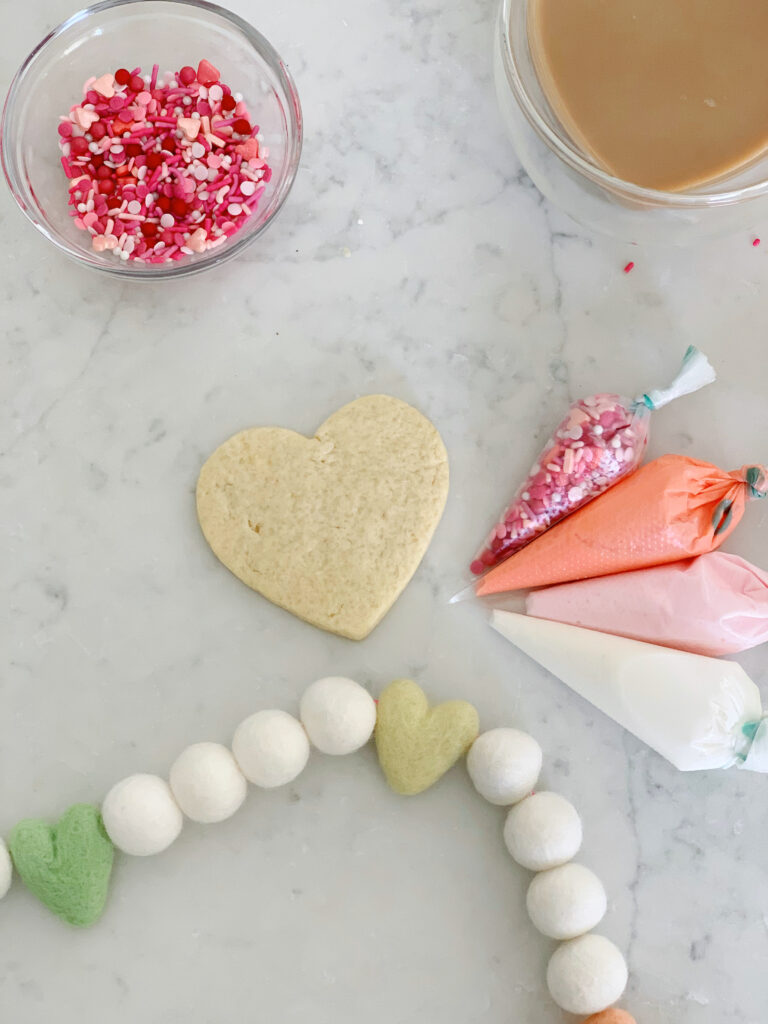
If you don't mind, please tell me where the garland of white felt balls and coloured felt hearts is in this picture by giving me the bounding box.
[0,676,636,1024]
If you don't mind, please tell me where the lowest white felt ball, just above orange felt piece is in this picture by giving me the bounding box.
[547,935,627,1014]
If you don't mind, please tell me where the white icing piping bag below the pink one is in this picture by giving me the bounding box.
[490,610,768,773]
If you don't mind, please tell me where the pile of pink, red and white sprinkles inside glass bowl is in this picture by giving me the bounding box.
[58,60,271,263]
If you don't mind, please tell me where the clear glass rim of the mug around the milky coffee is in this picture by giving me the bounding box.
[497,0,768,209]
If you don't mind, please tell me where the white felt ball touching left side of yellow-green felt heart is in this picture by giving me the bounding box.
[299,676,376,754]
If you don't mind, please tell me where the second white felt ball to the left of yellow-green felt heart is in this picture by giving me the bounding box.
[232,711,309,790]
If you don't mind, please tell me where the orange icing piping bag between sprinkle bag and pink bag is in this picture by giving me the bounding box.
[475,455,768,597]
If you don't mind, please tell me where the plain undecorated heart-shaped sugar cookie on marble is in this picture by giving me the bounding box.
[198,395,449,640]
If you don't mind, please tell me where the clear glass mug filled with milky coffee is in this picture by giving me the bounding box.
[494,0,768,245]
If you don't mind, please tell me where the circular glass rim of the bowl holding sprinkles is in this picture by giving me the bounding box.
[0,0,304,282]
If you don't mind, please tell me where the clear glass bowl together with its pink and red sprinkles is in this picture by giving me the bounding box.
[0,0,303,281]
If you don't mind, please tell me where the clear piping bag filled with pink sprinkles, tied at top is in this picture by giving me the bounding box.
[470,346,716,577]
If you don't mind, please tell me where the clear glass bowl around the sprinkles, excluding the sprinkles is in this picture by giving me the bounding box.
[0,0,302,280]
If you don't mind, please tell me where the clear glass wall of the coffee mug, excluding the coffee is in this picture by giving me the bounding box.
[494,0,768,245]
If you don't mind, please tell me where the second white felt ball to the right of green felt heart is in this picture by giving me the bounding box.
[169,743,248,824]
